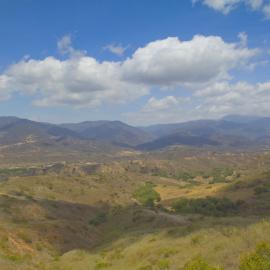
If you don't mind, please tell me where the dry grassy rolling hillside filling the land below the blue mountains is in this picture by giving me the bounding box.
[0,149,270,270]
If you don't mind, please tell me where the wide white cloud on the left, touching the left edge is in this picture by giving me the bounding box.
[0,56,148,107]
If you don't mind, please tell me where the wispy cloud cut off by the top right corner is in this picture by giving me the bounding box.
[192,0,268,16]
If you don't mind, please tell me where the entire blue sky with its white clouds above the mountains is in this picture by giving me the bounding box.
[0,0,270,126]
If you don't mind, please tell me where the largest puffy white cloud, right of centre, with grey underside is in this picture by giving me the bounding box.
[122,35,258,86]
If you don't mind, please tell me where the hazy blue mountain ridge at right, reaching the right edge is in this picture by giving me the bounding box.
[137,115,270,150]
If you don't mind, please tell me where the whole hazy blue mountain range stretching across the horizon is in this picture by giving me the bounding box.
[0,115,270,151]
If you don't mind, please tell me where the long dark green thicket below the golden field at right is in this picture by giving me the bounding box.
[172,197,239,216]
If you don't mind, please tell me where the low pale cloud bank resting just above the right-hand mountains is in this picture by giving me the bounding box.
[126,81,270,124]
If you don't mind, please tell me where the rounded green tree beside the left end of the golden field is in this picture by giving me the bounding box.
[133,182,160,206]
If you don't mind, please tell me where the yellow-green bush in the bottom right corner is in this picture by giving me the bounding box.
[239,243,270,270]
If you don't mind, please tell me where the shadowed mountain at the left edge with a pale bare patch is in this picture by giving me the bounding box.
[0,117,121,163]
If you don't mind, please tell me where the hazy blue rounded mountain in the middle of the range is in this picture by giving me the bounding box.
[61,121,155,146]
